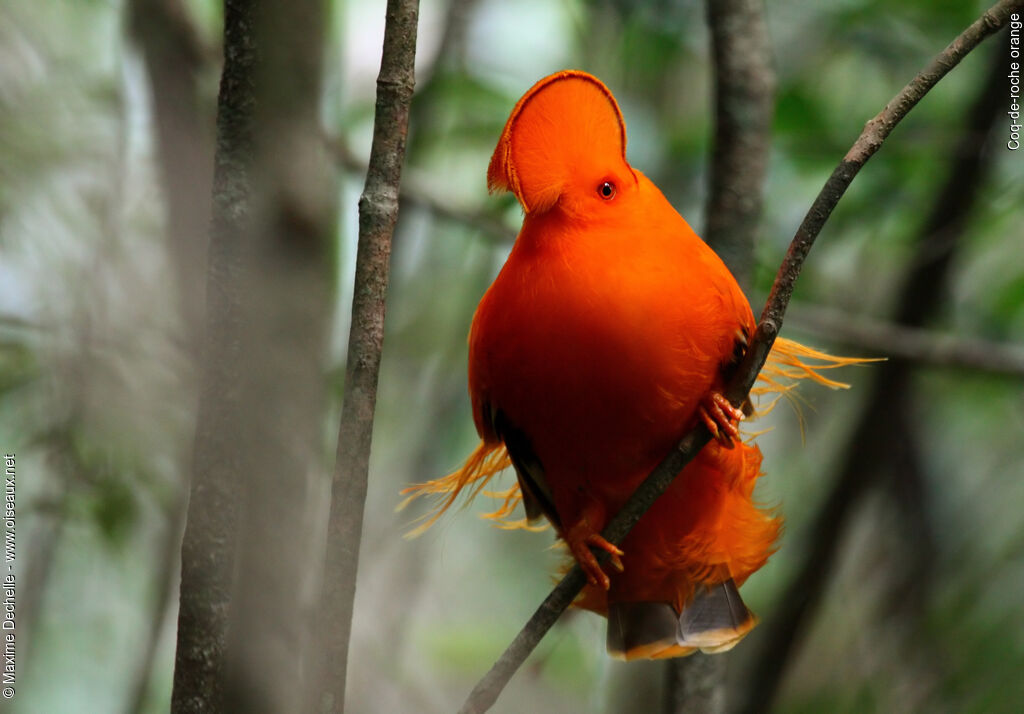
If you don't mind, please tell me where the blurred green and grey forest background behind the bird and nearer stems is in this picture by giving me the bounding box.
[0,0,1024,714]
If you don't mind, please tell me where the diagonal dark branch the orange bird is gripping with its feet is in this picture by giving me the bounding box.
[460,0,1022,714]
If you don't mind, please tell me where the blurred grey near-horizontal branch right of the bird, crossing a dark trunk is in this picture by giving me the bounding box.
[790,304,1024,377]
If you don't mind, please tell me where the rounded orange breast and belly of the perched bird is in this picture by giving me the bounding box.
[470,176,753,517]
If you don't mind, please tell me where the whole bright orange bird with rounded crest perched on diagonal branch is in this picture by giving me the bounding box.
[407,71,857,659]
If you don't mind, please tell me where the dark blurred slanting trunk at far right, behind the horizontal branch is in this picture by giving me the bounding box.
[738,32,1006,714]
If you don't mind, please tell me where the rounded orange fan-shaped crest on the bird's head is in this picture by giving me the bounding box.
[487,70,628,213]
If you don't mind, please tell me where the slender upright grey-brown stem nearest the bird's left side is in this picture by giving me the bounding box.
[317,0,419,712]
